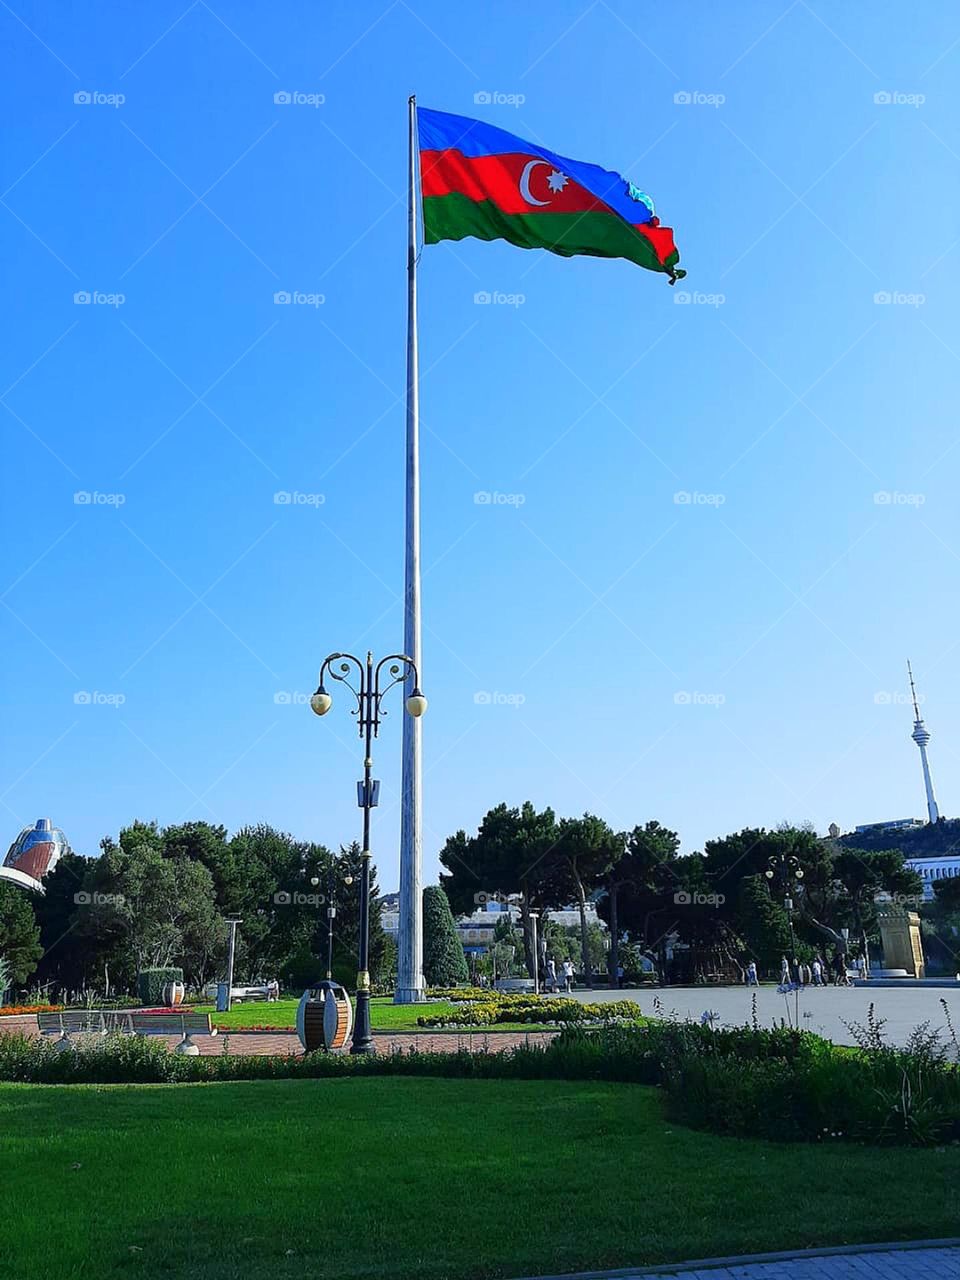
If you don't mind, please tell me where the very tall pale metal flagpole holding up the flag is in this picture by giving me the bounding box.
[394,96,426,1005]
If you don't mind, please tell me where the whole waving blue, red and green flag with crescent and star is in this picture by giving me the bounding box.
[417,110,686,284]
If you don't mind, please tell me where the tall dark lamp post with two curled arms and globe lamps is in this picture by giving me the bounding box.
[310,653,426,1053]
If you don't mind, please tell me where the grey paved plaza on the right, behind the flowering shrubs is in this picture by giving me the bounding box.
[573,983,960,1044]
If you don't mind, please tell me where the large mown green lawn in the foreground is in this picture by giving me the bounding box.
[0,1078,960,1280]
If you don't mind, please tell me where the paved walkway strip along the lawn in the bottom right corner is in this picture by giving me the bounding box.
[527,1240,960,1280]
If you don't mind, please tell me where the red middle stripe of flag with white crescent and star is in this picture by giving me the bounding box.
[420,148,617,216]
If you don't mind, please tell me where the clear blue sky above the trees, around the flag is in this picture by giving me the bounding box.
[0,0,960,888]
